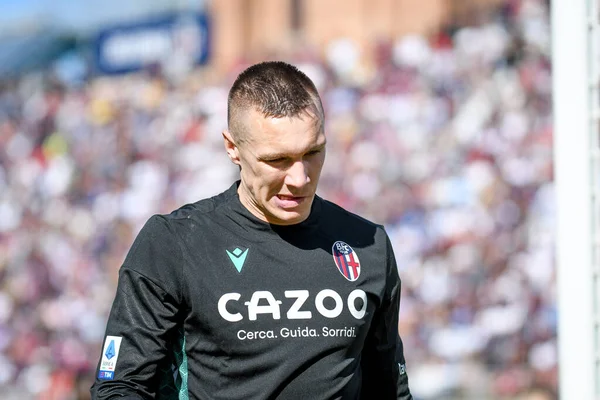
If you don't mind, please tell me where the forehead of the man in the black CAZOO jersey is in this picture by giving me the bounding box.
[244,110,325,155]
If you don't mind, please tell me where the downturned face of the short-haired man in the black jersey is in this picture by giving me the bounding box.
[223,110,326,225]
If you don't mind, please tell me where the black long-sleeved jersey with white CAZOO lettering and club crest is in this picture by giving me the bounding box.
[92,182,411,400]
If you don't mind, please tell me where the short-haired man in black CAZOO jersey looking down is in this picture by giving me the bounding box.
[92,62,412,400]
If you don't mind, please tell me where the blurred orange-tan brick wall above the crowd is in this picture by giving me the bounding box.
[208,0,504,68]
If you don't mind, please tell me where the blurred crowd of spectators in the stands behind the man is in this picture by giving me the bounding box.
[0,0,557,400]
